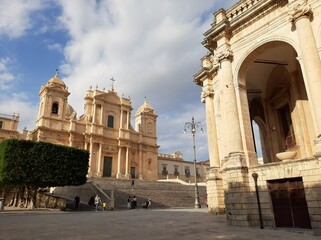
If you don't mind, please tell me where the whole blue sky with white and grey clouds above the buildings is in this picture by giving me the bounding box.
[0,0,237,161]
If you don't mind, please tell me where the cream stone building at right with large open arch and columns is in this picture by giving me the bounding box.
[194,0,321,232]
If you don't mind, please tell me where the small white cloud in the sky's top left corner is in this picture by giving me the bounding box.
[0,0,43,38]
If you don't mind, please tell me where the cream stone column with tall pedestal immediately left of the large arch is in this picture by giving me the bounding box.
[216,44,250,219]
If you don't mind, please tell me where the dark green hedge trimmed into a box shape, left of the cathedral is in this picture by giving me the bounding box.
[0,139,89,188]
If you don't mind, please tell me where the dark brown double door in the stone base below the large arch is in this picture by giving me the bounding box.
[268,177,311,228]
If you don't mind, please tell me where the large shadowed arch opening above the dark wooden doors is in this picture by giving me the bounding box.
[239,41,311,165]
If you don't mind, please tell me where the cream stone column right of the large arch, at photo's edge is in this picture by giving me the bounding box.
[288,0,321,149]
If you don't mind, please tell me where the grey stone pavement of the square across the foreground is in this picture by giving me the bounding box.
[0,208,321,240]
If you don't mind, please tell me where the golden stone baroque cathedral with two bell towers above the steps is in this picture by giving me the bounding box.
[0,72,159,180]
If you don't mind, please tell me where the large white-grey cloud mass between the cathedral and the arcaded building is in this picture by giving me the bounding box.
[53,0,235,160]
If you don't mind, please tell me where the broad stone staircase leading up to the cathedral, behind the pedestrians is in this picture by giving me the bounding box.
[54,178,206,209]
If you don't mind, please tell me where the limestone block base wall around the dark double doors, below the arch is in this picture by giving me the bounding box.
[220,159,321,230]
